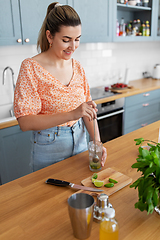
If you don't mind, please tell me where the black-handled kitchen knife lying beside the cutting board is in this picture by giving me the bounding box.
[46,178,103,192]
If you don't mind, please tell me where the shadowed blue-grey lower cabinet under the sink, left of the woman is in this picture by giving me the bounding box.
[0,125,32,184]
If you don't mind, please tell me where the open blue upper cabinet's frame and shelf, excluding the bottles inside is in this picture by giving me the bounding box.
[112,0,157,42]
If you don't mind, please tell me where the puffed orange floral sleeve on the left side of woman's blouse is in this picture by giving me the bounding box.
[14,59,41,118]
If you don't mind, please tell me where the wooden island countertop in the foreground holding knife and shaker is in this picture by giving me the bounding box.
[0,121,160,240]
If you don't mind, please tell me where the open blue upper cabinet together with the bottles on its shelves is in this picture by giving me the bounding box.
[113,0,157,42]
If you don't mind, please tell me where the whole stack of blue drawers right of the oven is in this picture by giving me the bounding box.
[123,89,160,134]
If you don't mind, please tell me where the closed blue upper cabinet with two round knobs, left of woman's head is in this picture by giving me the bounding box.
[0,0,67,45]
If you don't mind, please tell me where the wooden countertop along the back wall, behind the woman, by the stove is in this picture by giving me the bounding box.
[0,78,160,129]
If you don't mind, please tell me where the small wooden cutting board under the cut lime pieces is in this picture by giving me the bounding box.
[78,168,132,196]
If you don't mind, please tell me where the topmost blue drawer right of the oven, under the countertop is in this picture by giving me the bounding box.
[125,89,160,108]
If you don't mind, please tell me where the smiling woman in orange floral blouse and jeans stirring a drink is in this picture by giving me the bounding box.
[14,2,107,171]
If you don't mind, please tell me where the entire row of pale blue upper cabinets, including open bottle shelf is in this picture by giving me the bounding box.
[0,0,160,45]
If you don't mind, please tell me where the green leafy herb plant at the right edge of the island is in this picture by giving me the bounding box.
[130,138,160,214]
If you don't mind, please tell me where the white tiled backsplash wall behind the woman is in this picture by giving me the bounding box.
[0,42,160,105]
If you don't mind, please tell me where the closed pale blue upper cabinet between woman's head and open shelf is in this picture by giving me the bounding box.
[72,0,113,43]
